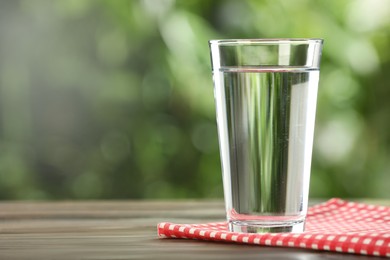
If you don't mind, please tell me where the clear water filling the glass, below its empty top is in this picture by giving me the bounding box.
[214,67,319,232]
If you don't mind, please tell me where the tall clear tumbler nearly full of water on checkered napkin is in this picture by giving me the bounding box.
[209,39,323,233]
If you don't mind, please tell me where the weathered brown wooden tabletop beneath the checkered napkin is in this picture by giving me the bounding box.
[0,201,384,260]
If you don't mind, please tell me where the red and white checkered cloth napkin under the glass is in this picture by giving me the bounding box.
[157,199,390,257]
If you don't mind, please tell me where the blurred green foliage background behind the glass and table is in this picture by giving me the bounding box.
[0,0,390,200]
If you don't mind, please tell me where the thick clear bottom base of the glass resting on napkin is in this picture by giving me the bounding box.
[229,220,305,233]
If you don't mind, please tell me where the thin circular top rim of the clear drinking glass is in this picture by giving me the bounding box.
[209,38,324,45]
